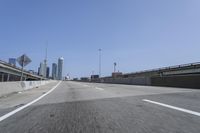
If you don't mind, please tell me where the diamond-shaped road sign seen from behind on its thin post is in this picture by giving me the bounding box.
[17,54,31,81]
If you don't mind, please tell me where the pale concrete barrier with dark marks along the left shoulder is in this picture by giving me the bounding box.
[0,80,55,97]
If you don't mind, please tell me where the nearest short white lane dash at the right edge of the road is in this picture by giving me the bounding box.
[143,99,200,116]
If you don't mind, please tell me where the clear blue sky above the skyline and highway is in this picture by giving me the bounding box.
[0,0,200,77]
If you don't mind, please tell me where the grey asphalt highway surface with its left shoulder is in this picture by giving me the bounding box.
[0,81,200,133]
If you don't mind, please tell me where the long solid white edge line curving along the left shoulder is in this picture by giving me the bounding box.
[0,81,62,122]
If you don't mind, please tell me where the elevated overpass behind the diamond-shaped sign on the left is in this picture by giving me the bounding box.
[0,60,46,82]
